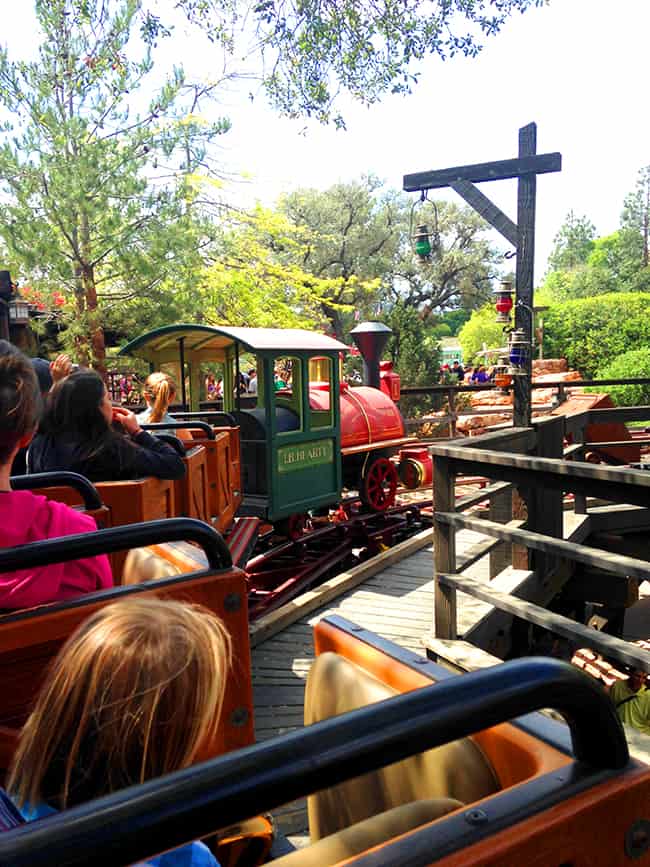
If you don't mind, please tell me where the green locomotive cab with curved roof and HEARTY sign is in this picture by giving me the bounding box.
[119,324,347,521]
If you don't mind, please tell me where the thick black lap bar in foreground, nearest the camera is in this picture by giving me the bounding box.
[0,657,629,867]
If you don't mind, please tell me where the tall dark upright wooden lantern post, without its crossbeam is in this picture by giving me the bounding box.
[513,123,537,427]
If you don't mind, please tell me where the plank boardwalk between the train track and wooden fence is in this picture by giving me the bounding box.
[252,530,487,833]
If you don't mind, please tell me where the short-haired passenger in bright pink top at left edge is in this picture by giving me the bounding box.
[0,347,113,609]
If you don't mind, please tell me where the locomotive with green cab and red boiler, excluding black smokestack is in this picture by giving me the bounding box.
[120,324,412,522]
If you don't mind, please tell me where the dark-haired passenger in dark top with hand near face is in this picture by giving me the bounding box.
[27,370,185,482]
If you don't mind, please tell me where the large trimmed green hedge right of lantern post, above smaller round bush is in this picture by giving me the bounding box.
[544,292,650,377]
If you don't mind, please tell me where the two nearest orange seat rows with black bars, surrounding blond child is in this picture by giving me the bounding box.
[0,519,650,867]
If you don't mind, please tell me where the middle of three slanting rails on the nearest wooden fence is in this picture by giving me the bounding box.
[436,512,650,584]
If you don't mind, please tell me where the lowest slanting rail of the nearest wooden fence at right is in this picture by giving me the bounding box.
[438,575,650,673]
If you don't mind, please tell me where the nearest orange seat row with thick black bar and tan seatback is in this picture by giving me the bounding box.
[0,617,650,867]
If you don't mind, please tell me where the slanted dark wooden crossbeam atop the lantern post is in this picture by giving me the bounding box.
[403,153,562,193]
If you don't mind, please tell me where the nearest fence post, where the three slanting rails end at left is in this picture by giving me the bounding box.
[433,457,457,639]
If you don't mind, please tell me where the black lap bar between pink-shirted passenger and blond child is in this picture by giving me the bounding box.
[0,518,232,576]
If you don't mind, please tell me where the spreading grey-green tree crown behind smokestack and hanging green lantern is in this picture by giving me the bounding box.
[279,177,501,339]
